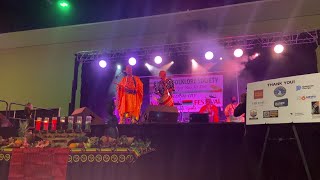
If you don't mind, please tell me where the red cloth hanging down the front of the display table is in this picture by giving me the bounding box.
[8,148,70,180]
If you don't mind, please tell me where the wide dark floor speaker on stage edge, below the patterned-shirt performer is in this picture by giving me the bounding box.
[143,105,179,123]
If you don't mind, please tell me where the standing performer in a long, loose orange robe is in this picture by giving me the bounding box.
[117,65,143,124]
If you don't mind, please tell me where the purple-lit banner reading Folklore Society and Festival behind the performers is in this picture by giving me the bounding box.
[149,74,223,112]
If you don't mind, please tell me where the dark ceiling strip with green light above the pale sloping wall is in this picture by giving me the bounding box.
[0,0,257,33]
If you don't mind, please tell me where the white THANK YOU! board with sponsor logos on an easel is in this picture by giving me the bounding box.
[246,73,320,125]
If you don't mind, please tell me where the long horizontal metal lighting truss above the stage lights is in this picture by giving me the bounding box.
[75,30,320,63]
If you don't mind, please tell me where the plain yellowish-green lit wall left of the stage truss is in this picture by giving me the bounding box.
[0,44,80,115]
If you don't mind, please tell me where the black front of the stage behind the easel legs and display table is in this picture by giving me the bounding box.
[0,123,320,180]
